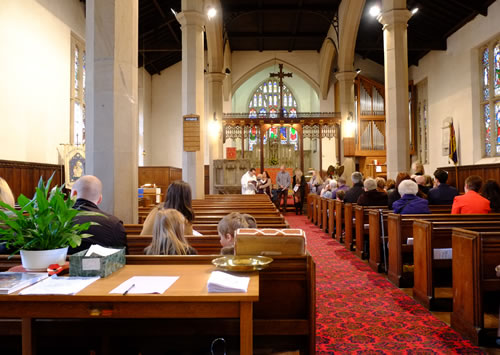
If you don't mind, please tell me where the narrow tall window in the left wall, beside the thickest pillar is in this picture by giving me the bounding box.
[70,34,85,145]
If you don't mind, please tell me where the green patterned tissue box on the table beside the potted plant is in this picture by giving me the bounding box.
[69,248,125,277]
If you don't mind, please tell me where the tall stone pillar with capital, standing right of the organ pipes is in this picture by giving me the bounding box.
[378,0,411,178]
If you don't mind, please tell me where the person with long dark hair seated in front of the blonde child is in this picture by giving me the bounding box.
[141,180,194,235]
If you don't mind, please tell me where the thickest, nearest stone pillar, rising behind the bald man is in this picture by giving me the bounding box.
[85,0,138,223]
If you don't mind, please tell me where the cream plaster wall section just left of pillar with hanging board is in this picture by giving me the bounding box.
[150,62,182,168]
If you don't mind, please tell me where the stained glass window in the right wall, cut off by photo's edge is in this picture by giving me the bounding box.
[479,39,500,157]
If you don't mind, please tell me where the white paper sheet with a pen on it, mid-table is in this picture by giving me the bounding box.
[109,276,179,295]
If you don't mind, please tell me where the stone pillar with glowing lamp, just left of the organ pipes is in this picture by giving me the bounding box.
[335,71,357,183]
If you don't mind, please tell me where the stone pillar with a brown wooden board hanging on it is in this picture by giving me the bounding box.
[177,6,206,199]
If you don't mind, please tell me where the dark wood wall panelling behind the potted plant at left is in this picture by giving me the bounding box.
[0,160,64,200]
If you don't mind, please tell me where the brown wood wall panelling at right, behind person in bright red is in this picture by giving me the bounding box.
[442,164,500,192]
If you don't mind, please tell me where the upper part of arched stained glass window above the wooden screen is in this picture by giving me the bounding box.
[248,79,298,118]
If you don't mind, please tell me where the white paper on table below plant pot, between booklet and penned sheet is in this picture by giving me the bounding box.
[19,275,100,295]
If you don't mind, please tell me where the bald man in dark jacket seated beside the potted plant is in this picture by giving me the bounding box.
[69,175,127,254]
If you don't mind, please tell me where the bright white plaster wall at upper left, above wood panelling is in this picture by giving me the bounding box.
[0,0,85,164]
